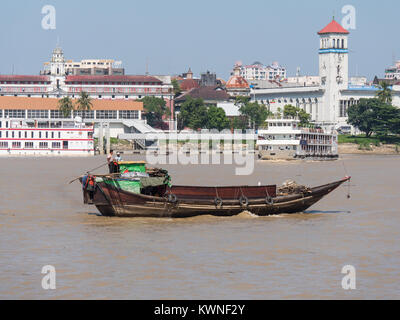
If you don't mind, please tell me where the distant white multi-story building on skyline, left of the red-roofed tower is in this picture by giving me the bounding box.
[240,62,286,81]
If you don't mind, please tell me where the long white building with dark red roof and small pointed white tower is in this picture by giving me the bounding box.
[0,47,174,125]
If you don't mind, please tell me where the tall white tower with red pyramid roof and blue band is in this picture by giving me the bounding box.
[318,19,349,123]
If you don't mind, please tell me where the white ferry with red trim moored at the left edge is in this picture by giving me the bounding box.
[0,117,94,157]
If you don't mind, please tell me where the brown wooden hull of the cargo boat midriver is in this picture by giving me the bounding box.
[85,178,350,218]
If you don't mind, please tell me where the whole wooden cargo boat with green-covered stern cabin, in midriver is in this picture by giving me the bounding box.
[81,162,350,218]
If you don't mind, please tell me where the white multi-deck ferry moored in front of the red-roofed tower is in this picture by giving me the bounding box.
[257,119,339,160]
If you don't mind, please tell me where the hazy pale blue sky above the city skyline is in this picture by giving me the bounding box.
[0,0,400,79]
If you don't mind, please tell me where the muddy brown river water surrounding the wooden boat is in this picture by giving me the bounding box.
[0,155,400,299]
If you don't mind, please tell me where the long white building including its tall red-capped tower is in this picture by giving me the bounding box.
[250,20,400,129]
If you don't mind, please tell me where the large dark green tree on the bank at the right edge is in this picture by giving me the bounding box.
[348,98,400,138]
